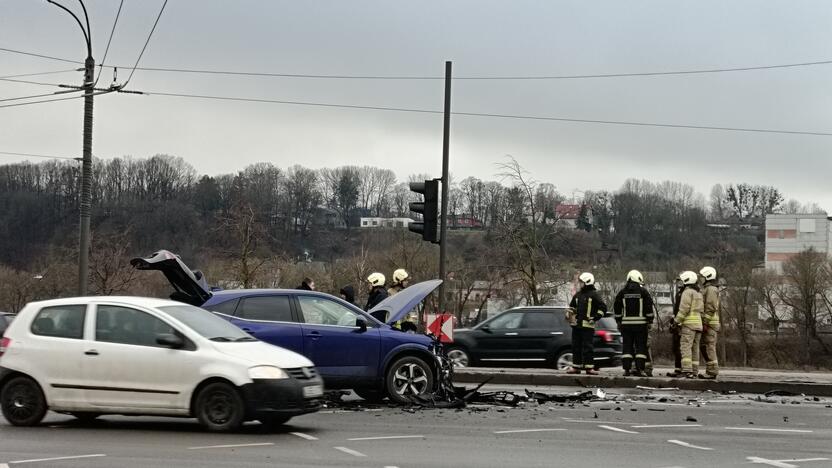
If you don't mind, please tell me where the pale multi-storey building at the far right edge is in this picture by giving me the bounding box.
[766,214,832,272]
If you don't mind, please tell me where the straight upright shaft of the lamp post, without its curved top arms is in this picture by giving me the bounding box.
[78,55,95,296]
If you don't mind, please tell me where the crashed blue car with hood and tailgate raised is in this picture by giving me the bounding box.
[131,250,442,403]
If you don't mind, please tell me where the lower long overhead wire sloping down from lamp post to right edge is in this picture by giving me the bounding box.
[143,91,832,136]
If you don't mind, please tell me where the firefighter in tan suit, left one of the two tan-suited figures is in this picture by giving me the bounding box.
[674,271,704,379]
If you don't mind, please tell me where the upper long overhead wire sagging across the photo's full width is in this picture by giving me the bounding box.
[0,47,832,81]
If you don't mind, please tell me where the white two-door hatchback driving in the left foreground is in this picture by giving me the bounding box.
[0,297,323,431]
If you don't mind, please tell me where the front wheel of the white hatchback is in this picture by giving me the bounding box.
[194,382,245,432]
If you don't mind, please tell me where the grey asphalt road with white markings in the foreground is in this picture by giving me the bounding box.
[0,387,832,468]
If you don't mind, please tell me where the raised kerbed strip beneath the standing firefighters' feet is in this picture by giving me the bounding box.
[454,367,832,397]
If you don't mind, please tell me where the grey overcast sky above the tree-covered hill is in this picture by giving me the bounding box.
[0,0,832,211]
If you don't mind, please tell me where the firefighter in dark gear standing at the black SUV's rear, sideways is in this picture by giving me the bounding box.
[566,273,607,375]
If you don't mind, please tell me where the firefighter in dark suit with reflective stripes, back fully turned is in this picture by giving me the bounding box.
[613,270,653,377]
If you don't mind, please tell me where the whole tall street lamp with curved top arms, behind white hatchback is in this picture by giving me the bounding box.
[46,0,95,296]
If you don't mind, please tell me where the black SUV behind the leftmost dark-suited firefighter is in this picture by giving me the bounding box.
[447,307,622,369]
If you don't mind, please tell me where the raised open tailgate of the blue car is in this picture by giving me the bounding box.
[130,250,211,307]
